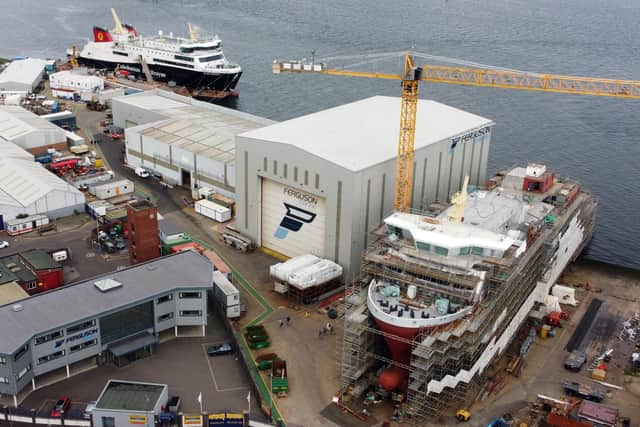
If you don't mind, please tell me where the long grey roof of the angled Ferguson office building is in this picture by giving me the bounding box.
[0,251,213,354]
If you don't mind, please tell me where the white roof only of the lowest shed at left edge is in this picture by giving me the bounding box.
[0,157,84,207]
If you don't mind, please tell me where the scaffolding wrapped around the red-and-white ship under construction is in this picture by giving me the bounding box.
[339,193,596,420]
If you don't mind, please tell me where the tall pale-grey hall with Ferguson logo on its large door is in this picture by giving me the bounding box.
[235,96,494,281]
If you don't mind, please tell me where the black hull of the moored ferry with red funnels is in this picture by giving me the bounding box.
[78,57,242,91]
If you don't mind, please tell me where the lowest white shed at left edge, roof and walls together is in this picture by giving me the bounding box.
[0,157,85,230]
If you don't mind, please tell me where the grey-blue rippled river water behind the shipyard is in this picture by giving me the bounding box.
[0,0,640,268]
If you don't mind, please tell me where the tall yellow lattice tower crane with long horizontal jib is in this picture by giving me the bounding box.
[272,52,640,212]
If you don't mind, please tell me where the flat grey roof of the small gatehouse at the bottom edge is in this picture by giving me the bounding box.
[96,380,167,412]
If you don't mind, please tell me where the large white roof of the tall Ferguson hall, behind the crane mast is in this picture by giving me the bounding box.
[240,96,494,171]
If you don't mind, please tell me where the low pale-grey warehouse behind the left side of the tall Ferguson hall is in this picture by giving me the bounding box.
[112,90,274,197]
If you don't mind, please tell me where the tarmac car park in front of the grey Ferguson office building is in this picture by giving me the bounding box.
[21,310,262,419]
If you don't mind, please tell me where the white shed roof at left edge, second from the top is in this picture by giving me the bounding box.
[0,105,67,142]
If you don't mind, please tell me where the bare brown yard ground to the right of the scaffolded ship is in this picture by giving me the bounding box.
[471,261,640,426]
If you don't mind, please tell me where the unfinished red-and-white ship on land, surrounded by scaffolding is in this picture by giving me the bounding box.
[341,164,597,419]
